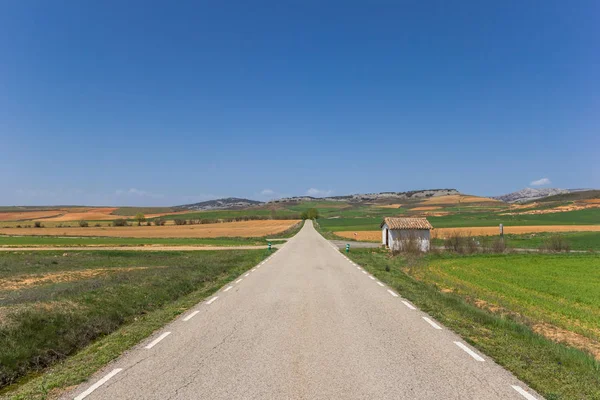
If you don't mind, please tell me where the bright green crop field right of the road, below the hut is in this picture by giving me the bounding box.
[409,254,600,344]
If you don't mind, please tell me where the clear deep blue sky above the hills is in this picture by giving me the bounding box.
[0,0,600,205]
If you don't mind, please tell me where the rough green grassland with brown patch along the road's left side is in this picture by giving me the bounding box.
[0,250,266,399]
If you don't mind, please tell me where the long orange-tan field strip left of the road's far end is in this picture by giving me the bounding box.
[0,220,300,238]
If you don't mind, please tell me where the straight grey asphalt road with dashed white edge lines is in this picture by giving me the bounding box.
[65,223,541,400]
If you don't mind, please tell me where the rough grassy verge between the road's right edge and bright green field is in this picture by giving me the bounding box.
[350,249,600,400]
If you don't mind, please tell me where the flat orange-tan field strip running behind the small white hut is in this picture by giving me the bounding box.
[334,225,600,242]
